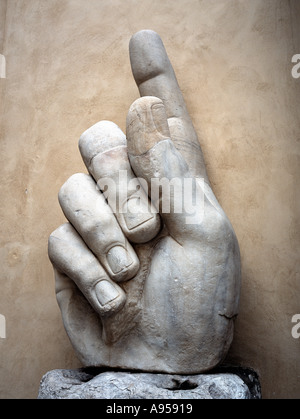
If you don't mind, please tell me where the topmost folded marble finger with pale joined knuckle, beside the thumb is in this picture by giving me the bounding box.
[79,121,160,243]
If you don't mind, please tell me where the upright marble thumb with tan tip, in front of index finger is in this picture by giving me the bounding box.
[127,96,204,243]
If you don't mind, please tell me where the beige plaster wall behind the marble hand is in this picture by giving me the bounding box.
[0,0,300,398]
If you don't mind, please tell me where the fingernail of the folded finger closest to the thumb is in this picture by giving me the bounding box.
[123,197,153,230]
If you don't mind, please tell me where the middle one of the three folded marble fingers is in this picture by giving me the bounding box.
[58,173,139,282]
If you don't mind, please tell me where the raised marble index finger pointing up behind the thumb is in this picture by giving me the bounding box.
[129,30,208,182]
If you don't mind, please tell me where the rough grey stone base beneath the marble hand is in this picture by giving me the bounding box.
[38,368,261,399]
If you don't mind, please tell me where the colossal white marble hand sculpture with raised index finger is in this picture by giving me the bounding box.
[49,30,240,374]
